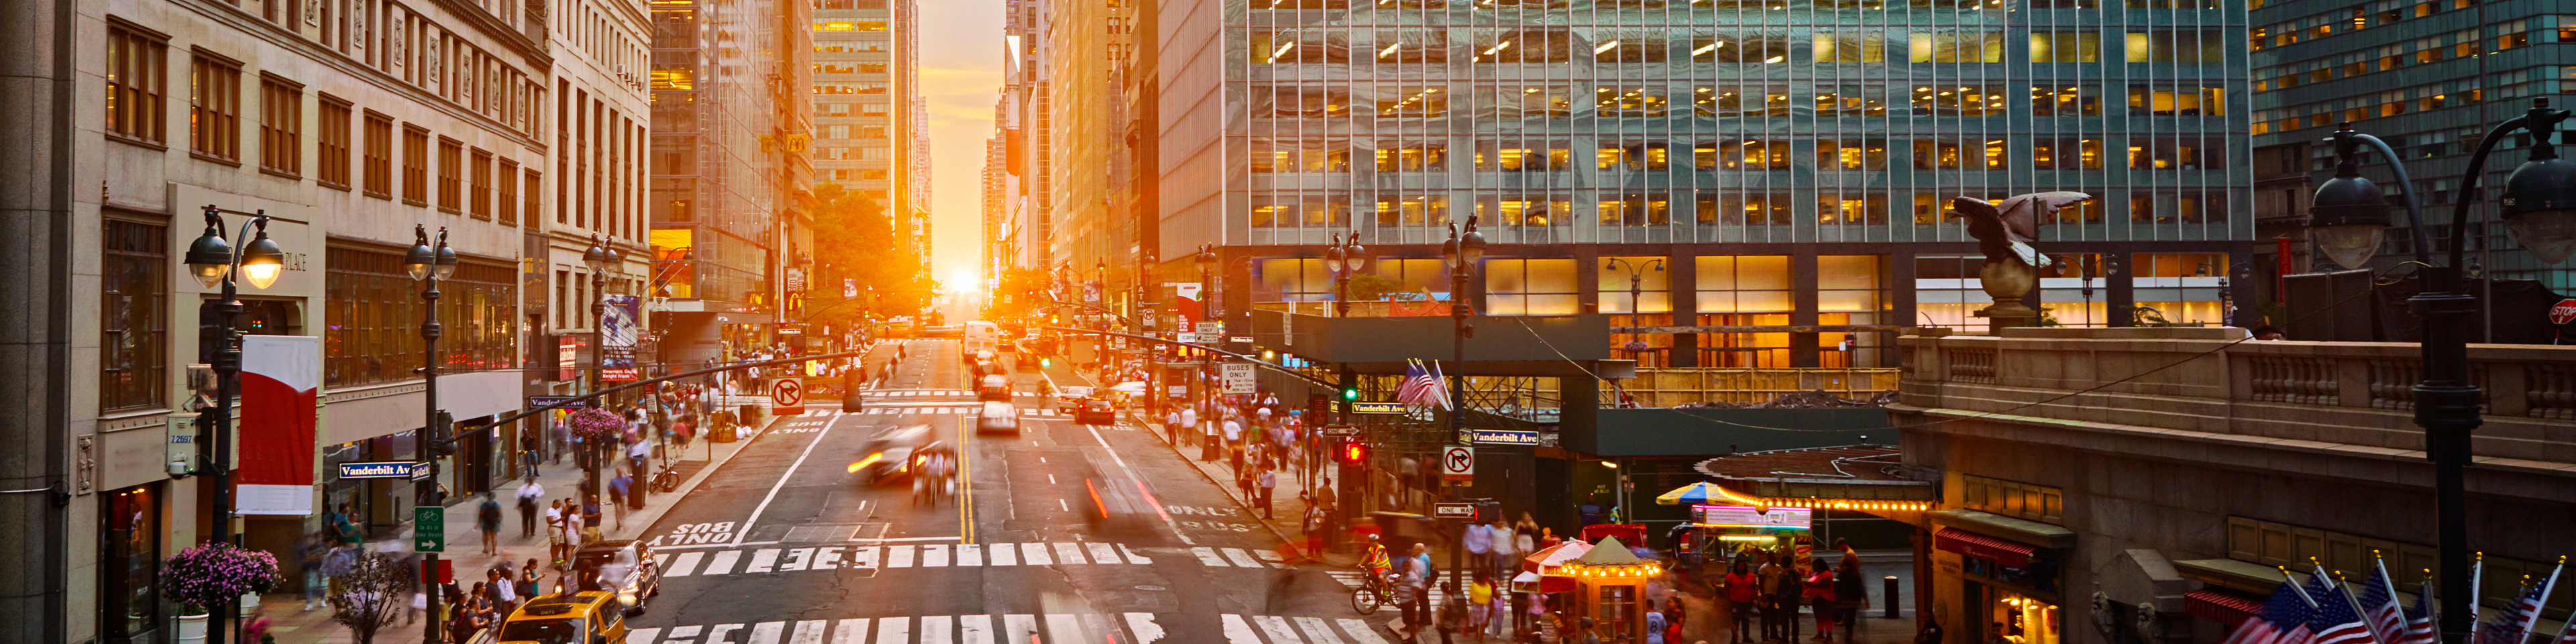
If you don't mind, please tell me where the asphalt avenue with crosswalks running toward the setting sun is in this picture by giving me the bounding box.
[629,340,1391,644]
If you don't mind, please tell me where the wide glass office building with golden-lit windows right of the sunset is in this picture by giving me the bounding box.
[1185,0,2254,366]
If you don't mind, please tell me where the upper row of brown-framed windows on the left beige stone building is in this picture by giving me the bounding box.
[103,23,539,227]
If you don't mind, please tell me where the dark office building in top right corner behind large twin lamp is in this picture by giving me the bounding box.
[2246,0,2576,291]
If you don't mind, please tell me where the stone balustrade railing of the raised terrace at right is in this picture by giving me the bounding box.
[1896,327,2576,464]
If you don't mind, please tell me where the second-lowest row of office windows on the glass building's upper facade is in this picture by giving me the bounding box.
[1249,137,2229,175]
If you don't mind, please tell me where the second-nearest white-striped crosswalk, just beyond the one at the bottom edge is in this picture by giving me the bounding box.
[654,541,1285,580]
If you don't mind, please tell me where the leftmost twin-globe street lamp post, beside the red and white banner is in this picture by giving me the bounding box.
[188,206,286,644]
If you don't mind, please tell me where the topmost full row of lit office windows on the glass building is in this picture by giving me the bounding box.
[1244,25,2233,64]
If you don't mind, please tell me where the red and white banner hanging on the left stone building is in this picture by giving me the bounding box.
[234,335,322,515]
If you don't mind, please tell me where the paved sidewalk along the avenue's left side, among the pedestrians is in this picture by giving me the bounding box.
[260,345,876,644]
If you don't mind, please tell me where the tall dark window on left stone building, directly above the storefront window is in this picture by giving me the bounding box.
[98,219,170,412]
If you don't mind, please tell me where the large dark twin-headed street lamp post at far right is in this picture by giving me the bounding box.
[2308,98,2576,644]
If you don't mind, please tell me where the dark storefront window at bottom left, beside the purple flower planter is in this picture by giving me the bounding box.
[98,484,162,641]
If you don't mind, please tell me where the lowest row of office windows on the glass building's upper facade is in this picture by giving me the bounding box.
[1247,188,2229,229]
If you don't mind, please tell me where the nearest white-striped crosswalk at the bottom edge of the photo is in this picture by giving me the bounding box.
[626,613,1386,644]
